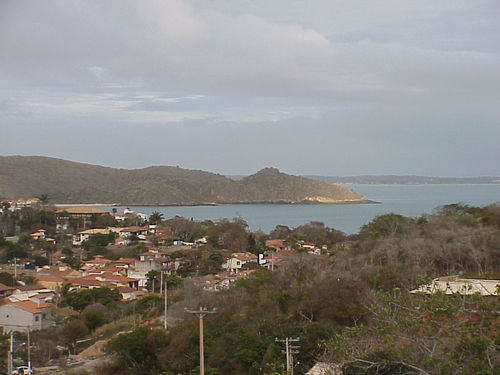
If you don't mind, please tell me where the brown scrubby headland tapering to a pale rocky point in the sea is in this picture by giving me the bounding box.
[0,156,370,205]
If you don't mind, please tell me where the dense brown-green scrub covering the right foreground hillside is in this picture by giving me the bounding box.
[102,205,500,375]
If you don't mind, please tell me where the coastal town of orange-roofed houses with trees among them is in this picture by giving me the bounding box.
[0,197,340,371]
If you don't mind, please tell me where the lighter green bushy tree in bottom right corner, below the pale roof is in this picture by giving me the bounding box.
[324,292,500,375]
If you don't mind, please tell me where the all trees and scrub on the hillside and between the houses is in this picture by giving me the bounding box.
[0,204,500,375]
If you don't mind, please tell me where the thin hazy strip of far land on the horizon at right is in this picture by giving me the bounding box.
[304,175,500,185]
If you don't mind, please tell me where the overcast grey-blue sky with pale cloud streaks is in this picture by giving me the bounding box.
[0,0,500,176]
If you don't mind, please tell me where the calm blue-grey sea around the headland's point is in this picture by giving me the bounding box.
[101,184,500,234]
